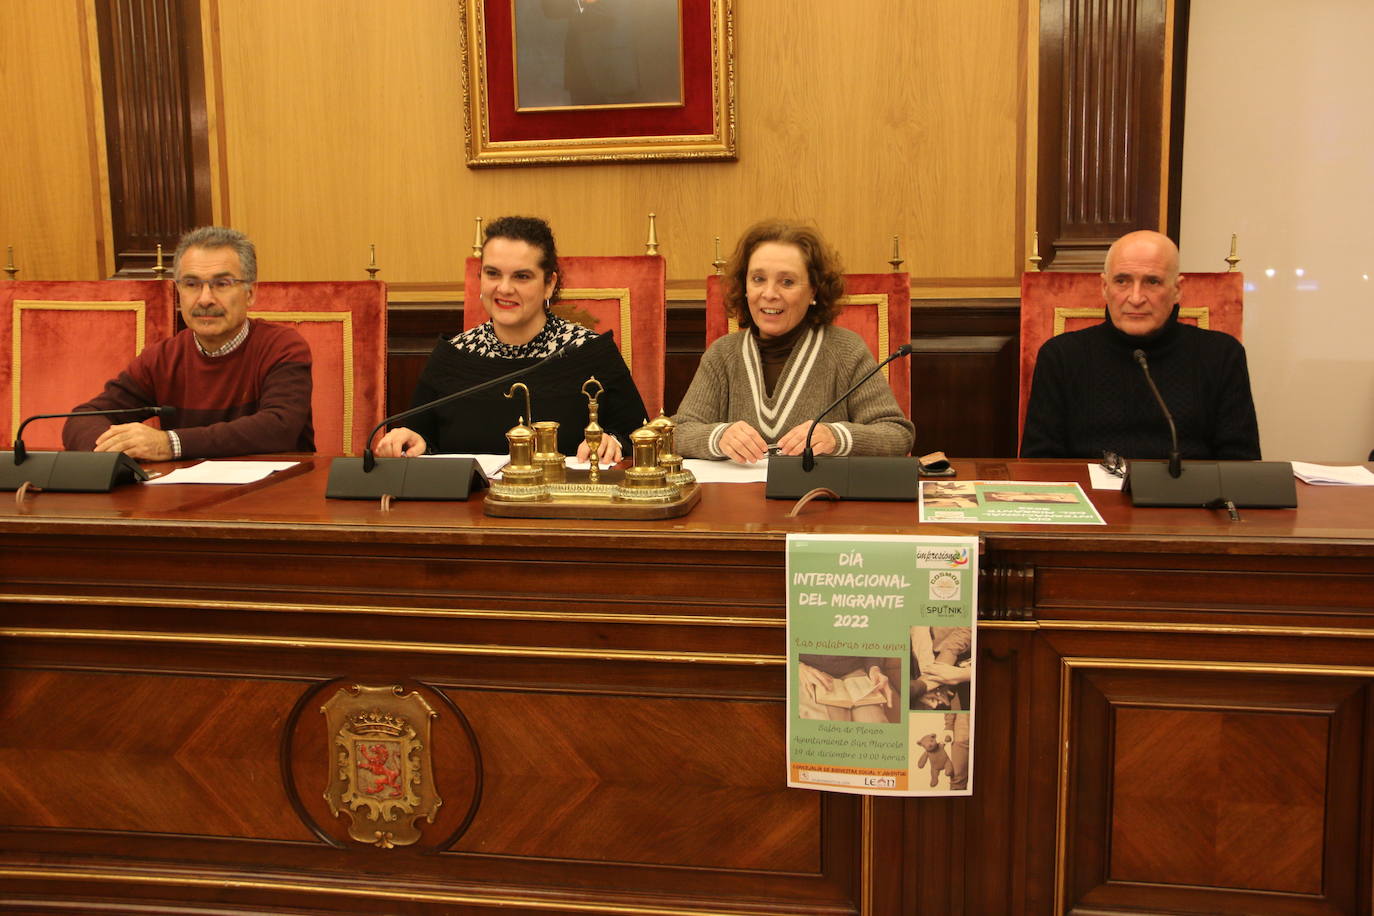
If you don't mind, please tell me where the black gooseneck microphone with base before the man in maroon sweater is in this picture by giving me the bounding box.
[0,404,176,493]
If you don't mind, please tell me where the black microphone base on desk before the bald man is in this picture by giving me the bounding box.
[1123,461,1297,509]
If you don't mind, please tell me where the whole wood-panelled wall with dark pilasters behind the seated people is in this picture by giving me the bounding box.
[0,0,1187,455]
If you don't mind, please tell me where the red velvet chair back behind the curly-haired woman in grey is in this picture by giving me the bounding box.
[706,273,911,419]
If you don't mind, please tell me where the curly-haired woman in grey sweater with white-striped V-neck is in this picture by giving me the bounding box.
[673,220,915,463]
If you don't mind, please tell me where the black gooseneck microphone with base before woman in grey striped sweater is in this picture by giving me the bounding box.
[764,343,921,500]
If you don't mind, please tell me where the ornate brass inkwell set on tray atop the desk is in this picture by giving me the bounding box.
[485,376,701,519]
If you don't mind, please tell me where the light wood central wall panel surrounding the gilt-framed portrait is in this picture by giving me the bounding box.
[207,0,1026,291]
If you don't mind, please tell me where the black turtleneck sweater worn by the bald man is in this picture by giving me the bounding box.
[1021,306,1260,460]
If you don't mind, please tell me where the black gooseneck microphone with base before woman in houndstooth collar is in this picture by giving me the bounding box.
[335,343,572,500]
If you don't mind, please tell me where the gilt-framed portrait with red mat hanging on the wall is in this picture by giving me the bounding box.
[459,0,735,166]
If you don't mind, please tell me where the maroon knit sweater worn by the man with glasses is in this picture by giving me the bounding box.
[62,319,315,457]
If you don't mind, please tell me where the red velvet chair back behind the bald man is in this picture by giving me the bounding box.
[1017,271,1245,442]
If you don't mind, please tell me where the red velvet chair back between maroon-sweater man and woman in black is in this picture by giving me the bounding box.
[249,280,386,456]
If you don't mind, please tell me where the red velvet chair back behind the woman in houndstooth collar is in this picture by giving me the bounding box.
[463,254,668,417]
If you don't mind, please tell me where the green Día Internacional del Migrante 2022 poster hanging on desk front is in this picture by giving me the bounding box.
[787,534,978,795]
